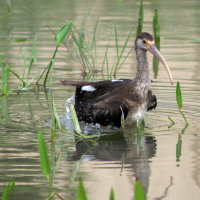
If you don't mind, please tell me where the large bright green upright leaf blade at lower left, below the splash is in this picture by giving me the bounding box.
[38,132,51,182]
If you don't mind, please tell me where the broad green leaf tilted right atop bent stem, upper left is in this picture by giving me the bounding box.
[55,21,72,44]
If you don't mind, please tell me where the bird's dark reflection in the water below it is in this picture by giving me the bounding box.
[73,128,156,192]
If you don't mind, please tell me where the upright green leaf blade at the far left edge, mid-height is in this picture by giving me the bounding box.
[1,65,10,95]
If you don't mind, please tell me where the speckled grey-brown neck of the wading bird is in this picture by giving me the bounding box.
[135,49,151,89]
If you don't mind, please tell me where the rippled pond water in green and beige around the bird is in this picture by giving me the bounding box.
[0,0,200,200]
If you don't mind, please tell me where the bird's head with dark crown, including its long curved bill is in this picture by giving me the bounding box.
[135,32,173,85]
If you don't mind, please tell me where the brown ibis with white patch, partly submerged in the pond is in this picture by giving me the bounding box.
[61,32,173,127]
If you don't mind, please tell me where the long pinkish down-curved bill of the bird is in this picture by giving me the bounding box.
[148,43,174,85]
